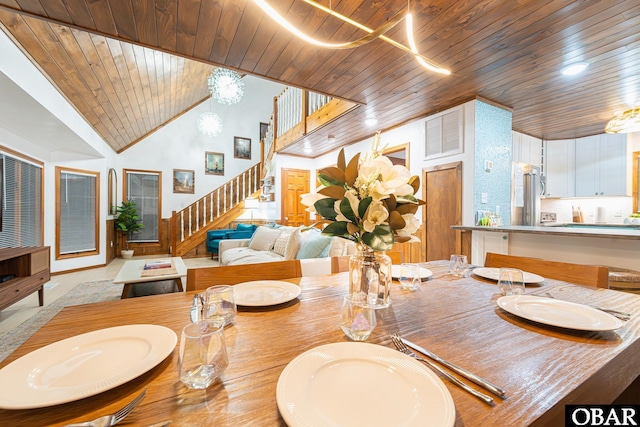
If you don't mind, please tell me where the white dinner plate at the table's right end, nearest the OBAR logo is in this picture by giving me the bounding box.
[497,295,624,331]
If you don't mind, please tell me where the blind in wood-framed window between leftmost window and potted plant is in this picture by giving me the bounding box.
[58,171,97,255]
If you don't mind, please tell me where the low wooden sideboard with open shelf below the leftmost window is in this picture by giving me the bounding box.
[0,246,51,310]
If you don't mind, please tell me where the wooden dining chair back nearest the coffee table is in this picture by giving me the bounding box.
[187,259,302,292]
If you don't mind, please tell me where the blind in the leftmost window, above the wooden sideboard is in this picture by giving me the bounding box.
[0,153,43,248]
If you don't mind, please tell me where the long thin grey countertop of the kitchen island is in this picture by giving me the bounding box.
[451,223,640,240]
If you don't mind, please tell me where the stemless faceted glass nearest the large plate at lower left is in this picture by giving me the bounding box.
[178,320,229,389]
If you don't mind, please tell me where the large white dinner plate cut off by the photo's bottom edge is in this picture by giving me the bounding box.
[276,342,456,427]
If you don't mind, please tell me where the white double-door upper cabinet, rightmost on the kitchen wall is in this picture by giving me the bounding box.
[576,134,627,197]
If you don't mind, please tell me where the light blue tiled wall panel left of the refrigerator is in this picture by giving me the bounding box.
[474,101,512,225]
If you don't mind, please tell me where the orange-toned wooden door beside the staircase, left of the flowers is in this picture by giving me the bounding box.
[281,169,309,227]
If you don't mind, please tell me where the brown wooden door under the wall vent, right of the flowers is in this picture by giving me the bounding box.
[422,162,462,261]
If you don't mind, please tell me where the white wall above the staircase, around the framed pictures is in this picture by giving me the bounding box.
[113,76,284,218]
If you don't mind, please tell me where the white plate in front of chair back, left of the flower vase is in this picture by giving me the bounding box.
[233,280,301,307]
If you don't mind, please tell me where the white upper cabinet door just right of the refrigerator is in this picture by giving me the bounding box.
[543,139,576,197]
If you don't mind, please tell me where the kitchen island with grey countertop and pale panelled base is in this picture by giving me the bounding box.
[451,223,640,270]
